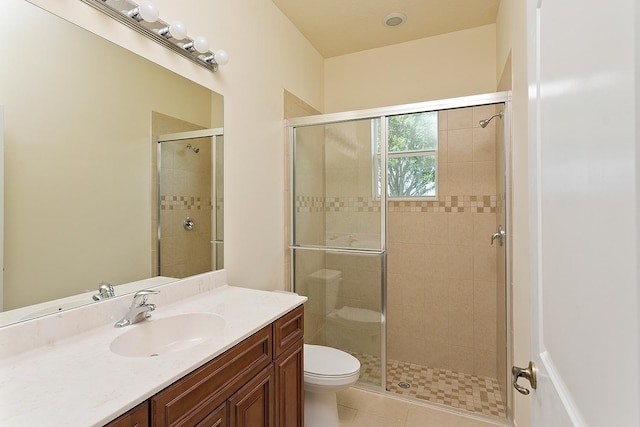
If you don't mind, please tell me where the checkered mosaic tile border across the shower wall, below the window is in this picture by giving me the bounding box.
[296,194,506,213]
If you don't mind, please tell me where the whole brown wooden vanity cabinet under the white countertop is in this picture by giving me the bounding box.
[107,306,304,427]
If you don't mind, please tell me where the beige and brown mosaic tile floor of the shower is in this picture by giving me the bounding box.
[353,353,506,418]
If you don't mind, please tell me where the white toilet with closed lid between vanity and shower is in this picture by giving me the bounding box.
[304,344,360,427]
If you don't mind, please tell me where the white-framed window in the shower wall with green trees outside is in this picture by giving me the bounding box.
[376,111,438,199]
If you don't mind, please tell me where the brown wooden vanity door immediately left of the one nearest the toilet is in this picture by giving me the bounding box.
[229,365,275,427]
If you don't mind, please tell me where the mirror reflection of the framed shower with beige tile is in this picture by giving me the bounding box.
[154,128,224,278]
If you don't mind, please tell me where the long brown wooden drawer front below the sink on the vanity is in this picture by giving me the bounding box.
[151,326,272,427]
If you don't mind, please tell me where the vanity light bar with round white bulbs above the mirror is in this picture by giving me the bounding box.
[81,0,229,72]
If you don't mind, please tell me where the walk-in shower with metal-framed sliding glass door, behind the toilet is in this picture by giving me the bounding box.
[288,93,510,419]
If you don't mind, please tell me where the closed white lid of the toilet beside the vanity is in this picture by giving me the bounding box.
[304,344,360,376]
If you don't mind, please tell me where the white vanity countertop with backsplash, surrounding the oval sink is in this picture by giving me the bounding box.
[0,273,306,427]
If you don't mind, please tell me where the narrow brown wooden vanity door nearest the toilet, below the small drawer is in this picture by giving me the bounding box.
[275,339,304,427]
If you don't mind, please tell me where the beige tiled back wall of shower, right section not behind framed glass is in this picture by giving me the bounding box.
[387,106,504,378]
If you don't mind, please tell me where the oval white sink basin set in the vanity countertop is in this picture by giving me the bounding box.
[110,313,226,357]
